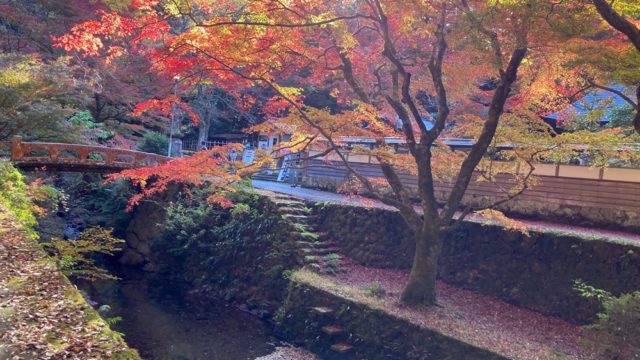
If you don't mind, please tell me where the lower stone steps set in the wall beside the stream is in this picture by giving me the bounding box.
[311,306,354,360]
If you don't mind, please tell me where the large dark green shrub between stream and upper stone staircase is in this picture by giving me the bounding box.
[151,190,297,314]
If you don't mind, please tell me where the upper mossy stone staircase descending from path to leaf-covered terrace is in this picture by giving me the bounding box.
[271,194,344,274]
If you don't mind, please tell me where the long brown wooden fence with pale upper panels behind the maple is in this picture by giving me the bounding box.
[303,150,640,230]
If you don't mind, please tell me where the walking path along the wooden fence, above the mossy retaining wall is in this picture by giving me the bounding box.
[253,180,640,245]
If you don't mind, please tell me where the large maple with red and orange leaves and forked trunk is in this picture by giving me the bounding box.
[57,0,636,304]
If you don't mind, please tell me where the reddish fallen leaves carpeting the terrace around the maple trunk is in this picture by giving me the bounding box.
[298,258,590,360]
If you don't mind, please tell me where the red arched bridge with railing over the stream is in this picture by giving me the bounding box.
[0,136,171,173]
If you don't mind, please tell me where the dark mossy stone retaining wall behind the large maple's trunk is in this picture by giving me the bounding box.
[315,204,640,323]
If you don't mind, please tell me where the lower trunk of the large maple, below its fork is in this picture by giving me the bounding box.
[400,230,442,305]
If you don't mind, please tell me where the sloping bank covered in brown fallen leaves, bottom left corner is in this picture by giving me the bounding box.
[0,207,139,360]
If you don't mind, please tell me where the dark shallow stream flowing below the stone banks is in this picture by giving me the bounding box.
[78,269,279,360]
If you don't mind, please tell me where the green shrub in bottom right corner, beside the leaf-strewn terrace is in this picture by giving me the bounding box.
[575,280,640,360]
